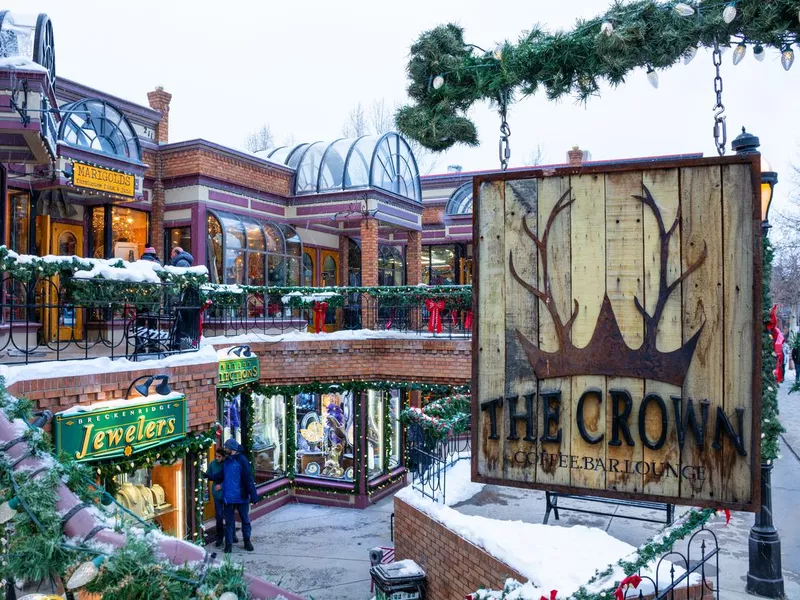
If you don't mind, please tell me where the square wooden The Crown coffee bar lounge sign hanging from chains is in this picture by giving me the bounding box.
[472,156,762,511]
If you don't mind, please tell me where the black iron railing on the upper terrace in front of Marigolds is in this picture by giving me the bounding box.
[0,274,202,364]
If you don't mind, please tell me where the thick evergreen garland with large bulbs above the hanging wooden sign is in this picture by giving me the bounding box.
[396,0,800,151]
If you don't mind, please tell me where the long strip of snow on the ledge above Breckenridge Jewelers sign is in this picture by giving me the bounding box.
[0,346,219,385]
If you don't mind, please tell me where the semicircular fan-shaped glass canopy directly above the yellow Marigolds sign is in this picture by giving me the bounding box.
[58,98,142,162]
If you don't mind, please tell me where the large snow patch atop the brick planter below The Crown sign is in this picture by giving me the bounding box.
[397,486,694,600]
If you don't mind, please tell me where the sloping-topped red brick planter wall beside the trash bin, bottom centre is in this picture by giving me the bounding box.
[394,497,527,600]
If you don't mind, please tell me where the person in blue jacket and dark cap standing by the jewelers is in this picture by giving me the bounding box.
[208,438,258,554]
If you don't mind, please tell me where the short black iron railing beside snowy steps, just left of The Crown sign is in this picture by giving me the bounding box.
[406,424,472,504]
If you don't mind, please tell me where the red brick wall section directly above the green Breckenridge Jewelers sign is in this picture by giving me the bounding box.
[8,363,219,431]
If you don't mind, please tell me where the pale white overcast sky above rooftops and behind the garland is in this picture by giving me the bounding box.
[4,0,800,210]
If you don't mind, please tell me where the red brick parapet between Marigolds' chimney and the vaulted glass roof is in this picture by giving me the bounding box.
[162,148,292,196]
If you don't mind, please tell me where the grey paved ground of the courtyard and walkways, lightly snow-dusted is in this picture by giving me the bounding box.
[210,378,800,600]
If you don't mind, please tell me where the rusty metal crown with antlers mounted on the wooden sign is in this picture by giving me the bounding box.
[508,186,708,386]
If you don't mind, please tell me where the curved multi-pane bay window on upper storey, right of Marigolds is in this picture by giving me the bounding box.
[208,210,303,286]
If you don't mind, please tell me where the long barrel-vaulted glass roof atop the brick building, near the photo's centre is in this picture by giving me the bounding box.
[259,133,422,202]
